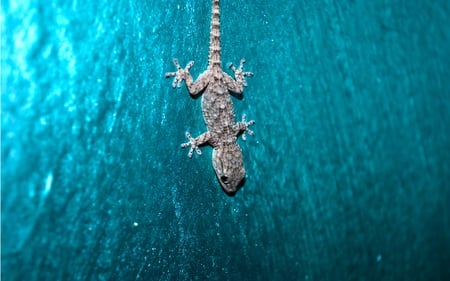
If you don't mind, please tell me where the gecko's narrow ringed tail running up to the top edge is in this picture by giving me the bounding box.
[208,0,221,68]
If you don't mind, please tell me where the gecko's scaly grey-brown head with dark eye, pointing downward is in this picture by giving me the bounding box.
[212,143,245,196]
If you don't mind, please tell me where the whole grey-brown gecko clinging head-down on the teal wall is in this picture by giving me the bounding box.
[165,0,255,196]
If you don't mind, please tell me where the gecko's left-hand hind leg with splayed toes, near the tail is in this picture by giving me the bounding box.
[165,59,207,96]
